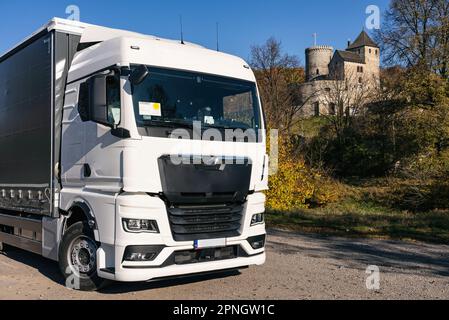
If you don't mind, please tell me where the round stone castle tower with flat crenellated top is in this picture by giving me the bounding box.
[306,46,334,81]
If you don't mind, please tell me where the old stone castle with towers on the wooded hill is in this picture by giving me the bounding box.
[299,31,380,117]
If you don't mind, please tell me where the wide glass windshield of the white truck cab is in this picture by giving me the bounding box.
[133,67,260,130]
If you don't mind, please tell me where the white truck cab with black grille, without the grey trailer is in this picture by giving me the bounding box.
[0,19,268,290]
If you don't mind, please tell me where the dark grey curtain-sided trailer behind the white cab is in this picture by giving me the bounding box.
[0,24,80,253]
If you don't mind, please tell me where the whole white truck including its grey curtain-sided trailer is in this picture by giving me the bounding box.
[0,18,268,290]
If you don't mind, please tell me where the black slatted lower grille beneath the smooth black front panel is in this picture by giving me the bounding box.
[168,204,243,241]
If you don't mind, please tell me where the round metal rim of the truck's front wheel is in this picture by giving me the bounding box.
[67,236,98,276]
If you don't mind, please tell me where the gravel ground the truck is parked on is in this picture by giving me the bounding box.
[0,230,449,300]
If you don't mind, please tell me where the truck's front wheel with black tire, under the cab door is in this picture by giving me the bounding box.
[59,222,106,291]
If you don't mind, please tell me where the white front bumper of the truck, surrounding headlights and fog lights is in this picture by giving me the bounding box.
[97,193,266,282]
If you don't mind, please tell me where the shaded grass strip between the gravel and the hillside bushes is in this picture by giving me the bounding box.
[267,180,449,243]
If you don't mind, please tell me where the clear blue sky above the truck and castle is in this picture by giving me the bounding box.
[0,0,389,62]
